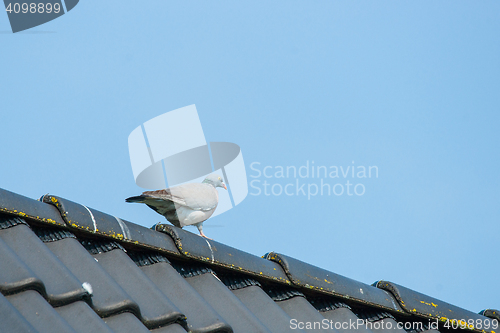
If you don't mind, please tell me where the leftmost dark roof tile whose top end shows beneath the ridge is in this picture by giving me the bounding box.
[0,220,89,306]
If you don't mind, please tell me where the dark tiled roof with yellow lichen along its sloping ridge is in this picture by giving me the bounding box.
[0,189,500,333]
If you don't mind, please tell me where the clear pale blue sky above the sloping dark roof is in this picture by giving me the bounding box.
[0,0,500,312]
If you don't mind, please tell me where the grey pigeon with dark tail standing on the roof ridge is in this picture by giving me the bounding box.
[125,174,227,238]
